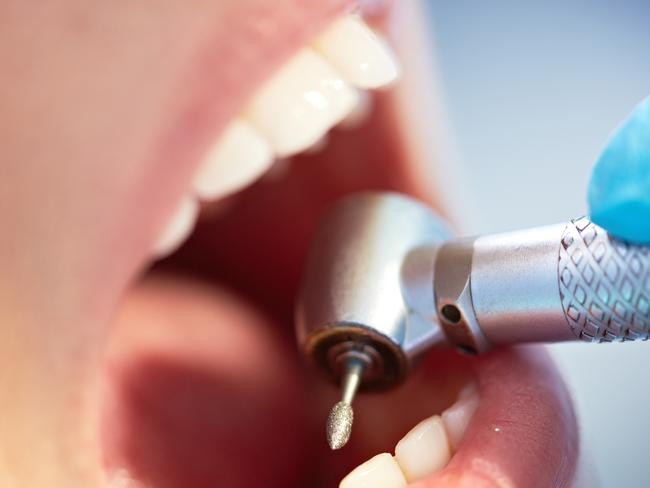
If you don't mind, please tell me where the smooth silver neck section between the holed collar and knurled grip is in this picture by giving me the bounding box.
[471,225,573,345]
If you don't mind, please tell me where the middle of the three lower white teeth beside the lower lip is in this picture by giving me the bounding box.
[395,415,451,482]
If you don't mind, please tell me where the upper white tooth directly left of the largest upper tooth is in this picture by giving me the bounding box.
[194,119,273,200]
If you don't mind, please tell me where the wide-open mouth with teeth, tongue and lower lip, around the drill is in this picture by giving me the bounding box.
[49,2,577,488]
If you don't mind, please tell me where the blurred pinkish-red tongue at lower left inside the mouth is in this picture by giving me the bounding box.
[102,274,306,488]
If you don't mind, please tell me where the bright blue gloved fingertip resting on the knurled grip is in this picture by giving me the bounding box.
[588,97,650,244]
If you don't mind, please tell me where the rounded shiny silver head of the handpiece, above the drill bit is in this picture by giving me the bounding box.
[296,193,449,388]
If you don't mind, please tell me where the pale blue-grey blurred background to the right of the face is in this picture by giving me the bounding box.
[427,0,650,488]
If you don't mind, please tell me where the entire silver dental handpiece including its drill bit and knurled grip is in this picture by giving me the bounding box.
[296,193,650,449]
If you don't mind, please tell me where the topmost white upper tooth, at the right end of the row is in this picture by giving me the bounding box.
[315,15,399,88]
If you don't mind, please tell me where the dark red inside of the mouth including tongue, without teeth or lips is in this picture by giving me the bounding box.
[102,93,469,488]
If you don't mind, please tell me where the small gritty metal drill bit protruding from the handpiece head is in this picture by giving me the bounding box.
[327,359,364,450]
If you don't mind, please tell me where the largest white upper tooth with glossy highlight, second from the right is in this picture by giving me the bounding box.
[246,48,358,157]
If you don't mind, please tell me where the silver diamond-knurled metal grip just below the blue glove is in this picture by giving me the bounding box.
[558,217,650,342]
